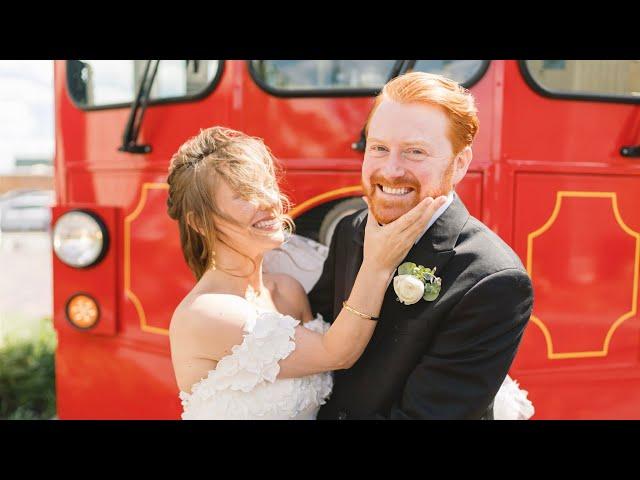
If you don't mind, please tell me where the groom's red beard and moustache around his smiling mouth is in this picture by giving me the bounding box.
[363,160,454,224]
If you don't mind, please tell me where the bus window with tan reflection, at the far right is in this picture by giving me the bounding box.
[521,60,640,102]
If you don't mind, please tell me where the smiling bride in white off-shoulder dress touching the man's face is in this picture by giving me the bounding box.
[167,127,533,420]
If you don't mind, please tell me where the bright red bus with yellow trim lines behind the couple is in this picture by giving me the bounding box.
[52,60,640,419]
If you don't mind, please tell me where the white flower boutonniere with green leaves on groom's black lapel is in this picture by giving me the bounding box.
[393,262,442,305]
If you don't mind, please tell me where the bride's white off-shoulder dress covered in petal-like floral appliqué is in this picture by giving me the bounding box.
[180,310,333,420]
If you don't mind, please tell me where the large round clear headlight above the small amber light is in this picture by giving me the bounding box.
[53,210,108,268]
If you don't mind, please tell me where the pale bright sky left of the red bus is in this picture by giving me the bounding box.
[0,60,54,174]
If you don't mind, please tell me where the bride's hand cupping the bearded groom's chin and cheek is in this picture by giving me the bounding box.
[363,196,447,274]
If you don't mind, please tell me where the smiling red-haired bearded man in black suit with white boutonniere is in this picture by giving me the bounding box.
[309,72,533,420]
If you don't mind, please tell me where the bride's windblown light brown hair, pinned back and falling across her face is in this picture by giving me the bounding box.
[167,126,294,280]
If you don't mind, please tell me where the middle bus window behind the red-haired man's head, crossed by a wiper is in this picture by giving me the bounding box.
[250,60,488,96]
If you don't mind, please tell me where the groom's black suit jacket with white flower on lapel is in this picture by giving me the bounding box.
[309,195,533,419]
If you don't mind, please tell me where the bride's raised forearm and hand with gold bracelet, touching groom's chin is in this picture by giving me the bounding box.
[278,197,445,378]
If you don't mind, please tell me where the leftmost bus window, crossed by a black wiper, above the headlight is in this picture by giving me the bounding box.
[67,60,221,109]
